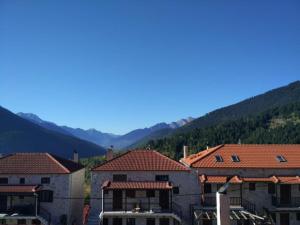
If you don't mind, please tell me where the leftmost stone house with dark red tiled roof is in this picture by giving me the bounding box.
[0,153,84,225]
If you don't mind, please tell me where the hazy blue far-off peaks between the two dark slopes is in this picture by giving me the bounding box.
[17,112,193,149]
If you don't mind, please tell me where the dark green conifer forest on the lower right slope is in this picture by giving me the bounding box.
[145,103,300,159]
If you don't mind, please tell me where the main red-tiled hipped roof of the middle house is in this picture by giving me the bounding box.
[93,150,190,171]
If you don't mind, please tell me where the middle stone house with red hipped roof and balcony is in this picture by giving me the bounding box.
[91,150,200,225]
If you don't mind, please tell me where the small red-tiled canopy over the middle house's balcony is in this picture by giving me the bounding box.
[102,181,172,190]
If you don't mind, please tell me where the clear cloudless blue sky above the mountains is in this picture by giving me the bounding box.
[0,0,300,134]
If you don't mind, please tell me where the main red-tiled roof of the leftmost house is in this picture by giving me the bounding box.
[0,153,83,174]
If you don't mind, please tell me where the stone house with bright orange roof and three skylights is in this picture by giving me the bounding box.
[181,144,300,225]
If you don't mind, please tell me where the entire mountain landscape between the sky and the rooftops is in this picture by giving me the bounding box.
[0,81,300,158]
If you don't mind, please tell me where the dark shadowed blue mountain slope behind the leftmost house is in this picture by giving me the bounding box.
[0,107,105,158]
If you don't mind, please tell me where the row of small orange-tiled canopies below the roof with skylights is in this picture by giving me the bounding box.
[199,174,300,184]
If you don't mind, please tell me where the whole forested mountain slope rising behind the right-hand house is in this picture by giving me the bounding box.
[140,81,300,158]
